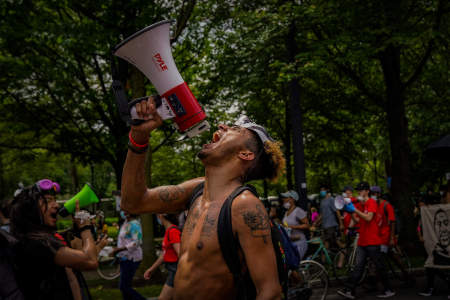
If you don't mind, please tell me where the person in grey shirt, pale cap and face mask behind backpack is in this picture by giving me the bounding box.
[280,190,309,260]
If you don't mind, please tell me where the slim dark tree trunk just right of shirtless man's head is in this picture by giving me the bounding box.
[286,23,307,210]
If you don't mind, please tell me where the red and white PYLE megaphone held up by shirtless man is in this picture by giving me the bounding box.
[113,20,210,137]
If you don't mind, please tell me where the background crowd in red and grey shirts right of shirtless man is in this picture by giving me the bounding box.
[268,182,450,299]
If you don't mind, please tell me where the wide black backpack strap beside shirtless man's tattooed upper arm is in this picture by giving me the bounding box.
[217,186,258,299]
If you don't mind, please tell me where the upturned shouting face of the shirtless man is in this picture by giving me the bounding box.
[197,124,251,164]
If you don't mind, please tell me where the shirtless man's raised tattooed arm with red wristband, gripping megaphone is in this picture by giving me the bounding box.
[120,98,204,214]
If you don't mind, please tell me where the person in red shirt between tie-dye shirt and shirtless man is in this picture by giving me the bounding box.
[144,214,181,300]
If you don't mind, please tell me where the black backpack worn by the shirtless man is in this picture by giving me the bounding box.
[188,182,300,300]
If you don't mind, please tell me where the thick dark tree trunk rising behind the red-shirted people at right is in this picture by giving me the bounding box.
[380,45,415,241]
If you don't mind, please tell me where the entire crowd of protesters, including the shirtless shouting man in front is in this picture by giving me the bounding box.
[0,98,448,300]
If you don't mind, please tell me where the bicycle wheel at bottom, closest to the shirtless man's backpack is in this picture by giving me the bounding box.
[288,260,328,300]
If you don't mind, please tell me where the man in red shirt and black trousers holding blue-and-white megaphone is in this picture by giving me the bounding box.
[338,182,395,299]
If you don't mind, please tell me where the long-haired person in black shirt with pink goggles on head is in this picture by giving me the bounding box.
[11,181,98,300]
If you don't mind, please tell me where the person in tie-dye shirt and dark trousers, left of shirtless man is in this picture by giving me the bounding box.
[110,210,146,300]
